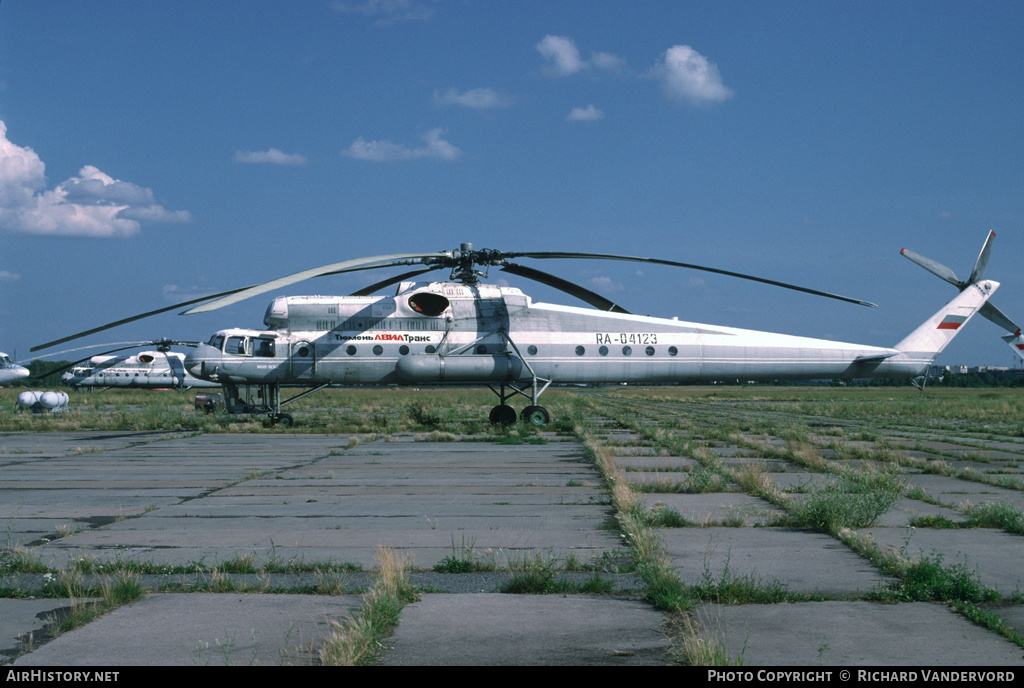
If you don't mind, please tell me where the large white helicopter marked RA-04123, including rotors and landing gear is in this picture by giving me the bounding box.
[33,234,1019,425]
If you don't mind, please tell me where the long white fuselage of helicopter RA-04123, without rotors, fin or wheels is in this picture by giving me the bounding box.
[185,276,932,393]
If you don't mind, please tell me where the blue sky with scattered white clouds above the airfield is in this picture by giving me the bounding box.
[0,0,1024,366]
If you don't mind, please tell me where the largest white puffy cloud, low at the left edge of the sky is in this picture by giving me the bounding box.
[0,121,191,238]
